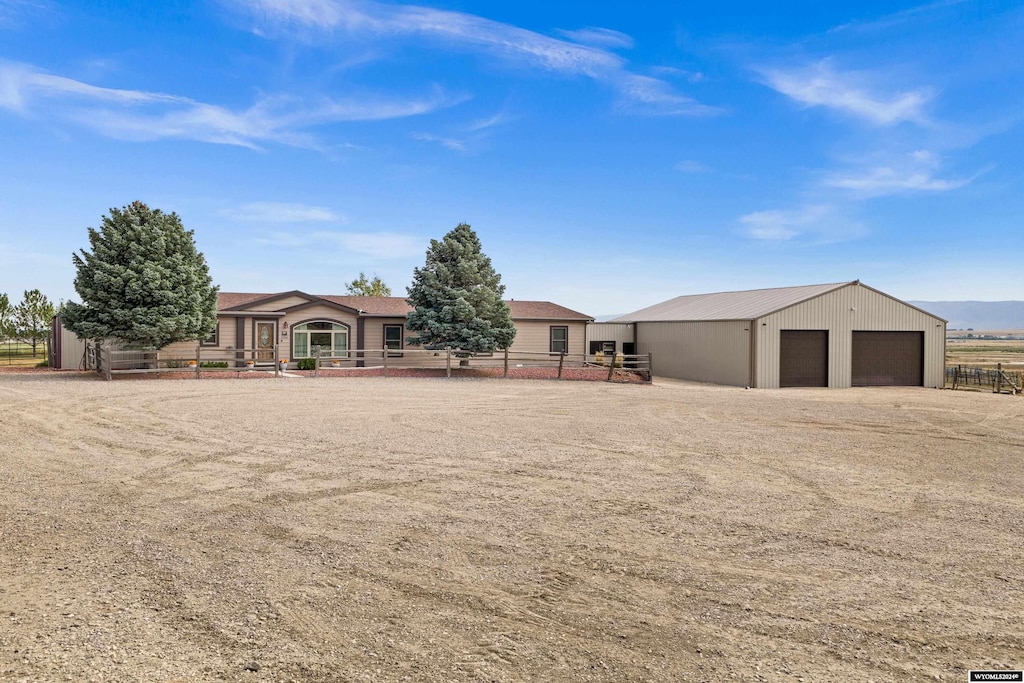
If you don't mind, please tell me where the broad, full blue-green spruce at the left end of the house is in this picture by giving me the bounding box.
[65,202,217,349]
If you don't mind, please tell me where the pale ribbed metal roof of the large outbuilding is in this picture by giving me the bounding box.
[609,280,859,323]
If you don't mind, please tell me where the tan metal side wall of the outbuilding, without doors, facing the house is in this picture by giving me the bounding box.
[636,321,751,386]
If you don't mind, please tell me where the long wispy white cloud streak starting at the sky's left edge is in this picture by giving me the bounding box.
[0,61,465,148]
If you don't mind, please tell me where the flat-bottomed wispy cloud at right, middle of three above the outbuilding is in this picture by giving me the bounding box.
[824,150,974,197]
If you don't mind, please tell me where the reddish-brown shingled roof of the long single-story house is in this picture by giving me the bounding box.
[217,291,594,322]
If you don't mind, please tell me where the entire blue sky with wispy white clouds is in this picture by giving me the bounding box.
[0,0,1024,315]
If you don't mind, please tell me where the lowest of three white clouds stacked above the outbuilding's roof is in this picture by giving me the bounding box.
[739,204,864,243]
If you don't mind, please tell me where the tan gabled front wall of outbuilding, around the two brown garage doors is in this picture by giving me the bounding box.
[756,284,946,389]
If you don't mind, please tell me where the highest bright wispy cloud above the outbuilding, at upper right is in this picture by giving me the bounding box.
[761,59,933,126]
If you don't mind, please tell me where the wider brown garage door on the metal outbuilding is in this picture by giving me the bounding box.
[852,332,925,386]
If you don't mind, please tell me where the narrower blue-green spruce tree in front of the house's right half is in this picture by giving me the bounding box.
[406,223,515,352]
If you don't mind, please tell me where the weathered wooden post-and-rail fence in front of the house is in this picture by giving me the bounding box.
[85,341,652,382]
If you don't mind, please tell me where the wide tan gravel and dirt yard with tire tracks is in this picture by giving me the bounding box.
[0,373,1024,682]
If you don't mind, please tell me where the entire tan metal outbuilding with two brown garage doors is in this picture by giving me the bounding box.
[588,281,946,389]
